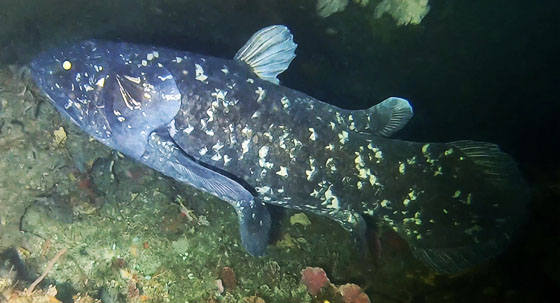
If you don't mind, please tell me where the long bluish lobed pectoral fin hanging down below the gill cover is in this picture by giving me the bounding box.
[140,130,271,256]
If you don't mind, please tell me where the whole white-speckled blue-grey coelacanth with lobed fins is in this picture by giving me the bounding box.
[29,25,530,273]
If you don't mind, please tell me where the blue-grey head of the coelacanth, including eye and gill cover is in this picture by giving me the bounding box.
[30,40,181,158]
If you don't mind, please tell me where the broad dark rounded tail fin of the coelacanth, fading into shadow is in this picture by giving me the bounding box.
[381,141,529,273]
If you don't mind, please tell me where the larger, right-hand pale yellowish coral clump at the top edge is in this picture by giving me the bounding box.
[375,0,430,26]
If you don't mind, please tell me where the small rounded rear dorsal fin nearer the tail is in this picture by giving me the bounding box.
[369,97,413,137]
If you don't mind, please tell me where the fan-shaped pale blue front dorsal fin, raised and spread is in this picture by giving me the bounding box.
[234,25,297,84]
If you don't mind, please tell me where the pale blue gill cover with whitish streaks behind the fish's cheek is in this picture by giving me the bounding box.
[97,64,181,159]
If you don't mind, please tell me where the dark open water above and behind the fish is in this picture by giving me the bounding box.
[0,0,560,302]
